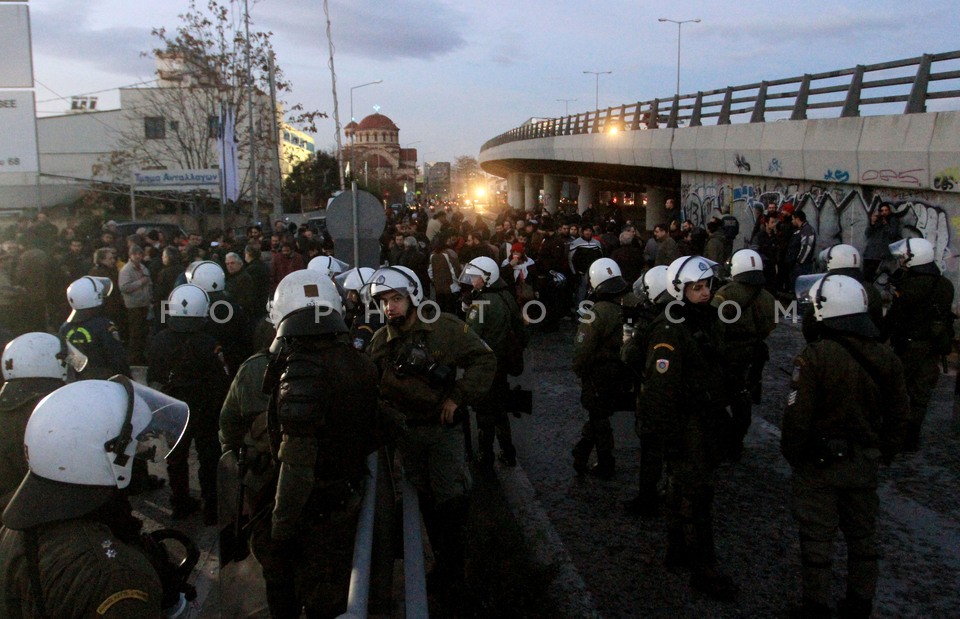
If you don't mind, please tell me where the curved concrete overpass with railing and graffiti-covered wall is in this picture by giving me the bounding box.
[479,51,960,296]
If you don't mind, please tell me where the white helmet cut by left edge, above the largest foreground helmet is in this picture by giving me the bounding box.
[2,332,87,382]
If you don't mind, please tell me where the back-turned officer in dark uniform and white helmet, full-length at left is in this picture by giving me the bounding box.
[147,284,230,525]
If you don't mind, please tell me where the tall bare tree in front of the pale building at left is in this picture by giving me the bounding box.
[103,0,326,208]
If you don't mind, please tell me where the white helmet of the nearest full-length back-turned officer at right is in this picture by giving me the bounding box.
[807,273,879,337]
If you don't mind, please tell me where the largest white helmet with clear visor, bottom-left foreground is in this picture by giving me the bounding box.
[3,376,189,530]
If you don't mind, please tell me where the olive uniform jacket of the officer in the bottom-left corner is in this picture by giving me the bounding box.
[0,519,163,619]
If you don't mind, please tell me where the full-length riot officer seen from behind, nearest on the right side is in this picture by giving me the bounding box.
[780,274,910,619]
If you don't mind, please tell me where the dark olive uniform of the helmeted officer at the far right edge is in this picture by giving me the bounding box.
[881,265,953,451]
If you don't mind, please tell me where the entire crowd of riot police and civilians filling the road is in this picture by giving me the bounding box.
[0,200,954,617]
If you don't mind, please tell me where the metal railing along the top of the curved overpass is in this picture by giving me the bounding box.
[480,50,960,151]
